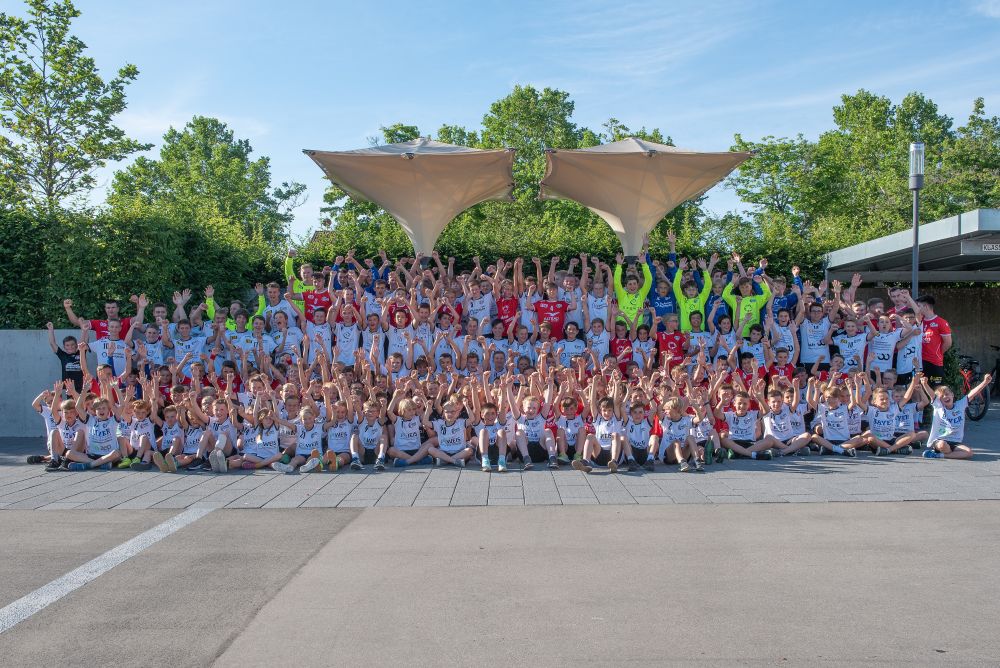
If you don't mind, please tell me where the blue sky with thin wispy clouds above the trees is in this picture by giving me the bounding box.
[64,0,1000,235]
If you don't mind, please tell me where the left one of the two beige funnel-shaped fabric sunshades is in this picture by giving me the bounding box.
[304,138,514,255]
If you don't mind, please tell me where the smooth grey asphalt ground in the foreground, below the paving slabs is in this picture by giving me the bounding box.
[0,501,1000,666]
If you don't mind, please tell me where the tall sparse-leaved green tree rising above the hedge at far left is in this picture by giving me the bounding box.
[0,0,150,214]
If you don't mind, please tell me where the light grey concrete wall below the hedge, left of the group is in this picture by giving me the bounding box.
[0,329,96,437]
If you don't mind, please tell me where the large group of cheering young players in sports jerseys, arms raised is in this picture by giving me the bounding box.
[30,235,991,473]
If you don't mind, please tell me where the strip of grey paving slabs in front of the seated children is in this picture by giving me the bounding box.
[0,410,1000,510]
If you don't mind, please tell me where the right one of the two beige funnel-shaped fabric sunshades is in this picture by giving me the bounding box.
[538,137,750,256]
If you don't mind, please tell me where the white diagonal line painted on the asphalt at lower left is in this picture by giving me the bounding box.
[0,508,213,633]
